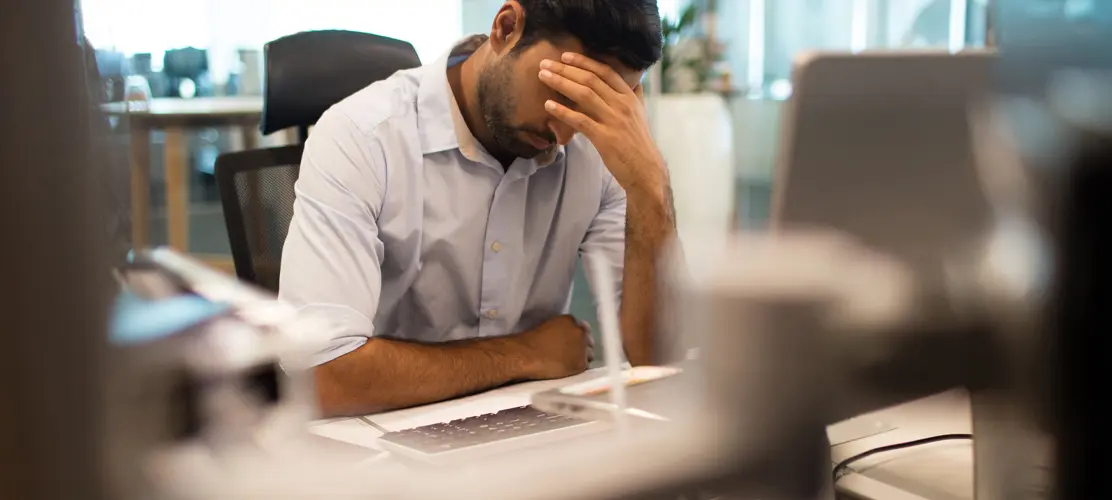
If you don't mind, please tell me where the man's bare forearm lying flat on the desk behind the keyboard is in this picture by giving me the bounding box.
[316,338,528,417]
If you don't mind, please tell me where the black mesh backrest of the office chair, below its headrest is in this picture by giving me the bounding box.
[216,146,302,292]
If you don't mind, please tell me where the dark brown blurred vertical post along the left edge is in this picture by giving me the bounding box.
[0,1,111,500]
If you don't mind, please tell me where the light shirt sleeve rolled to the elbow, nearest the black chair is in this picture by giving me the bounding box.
[278,110,386,364]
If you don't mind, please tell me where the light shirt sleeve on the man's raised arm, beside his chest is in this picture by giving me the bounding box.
[579,172,626,304]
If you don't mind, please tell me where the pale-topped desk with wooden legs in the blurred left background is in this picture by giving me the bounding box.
[102,97,262,270]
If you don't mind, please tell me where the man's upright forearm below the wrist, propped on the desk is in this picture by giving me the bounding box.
[622,173,676,366]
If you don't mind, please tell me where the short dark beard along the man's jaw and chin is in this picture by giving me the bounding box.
[478,57,556,159]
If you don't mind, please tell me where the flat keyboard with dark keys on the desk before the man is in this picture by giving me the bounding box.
[378,407,603,464]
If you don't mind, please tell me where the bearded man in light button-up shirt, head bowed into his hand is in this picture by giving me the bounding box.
[280,0,675,416]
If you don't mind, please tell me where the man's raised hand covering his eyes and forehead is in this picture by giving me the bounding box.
[539,52,667,193]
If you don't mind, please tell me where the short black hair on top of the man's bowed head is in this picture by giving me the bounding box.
[517,0,664,71]
